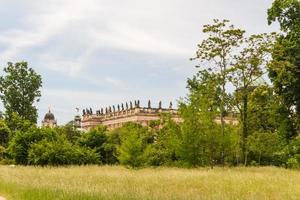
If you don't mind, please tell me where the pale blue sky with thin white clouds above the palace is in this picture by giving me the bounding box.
[0,0,278,125]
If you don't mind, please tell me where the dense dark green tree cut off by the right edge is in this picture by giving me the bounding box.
[268,0,300,134]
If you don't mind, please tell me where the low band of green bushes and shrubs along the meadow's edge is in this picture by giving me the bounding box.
[0,112,300,169]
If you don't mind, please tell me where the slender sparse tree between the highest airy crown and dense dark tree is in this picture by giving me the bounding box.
[230,34,275,161]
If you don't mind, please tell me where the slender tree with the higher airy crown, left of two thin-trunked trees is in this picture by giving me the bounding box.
[194,20,244,160]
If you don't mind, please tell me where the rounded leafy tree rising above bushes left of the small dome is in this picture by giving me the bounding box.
[0,62,42,123]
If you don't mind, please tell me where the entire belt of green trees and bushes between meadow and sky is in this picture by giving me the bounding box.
[0,0,300,168]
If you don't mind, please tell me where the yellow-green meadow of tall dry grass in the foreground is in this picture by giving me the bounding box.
[0,166,300,200]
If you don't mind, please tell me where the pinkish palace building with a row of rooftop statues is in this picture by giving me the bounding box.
[81,100,182,131]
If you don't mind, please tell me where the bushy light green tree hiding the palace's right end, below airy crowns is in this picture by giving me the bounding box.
[179,70,226,167]
